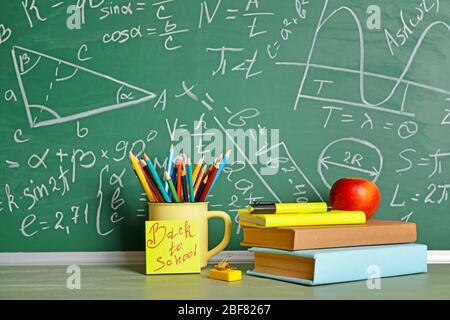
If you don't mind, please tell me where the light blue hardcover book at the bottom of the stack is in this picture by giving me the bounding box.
[247,243,427,286]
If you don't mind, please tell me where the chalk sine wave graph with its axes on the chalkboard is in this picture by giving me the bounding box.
[276,0,450,117]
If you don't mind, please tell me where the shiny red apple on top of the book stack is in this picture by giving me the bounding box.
[330,178,380,219]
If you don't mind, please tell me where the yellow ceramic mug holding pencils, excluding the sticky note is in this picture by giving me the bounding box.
[148,202,231,268]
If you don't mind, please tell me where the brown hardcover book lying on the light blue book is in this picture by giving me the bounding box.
[241,220,417,250]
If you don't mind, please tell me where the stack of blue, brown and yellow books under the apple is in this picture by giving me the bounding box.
[239,202,427,285]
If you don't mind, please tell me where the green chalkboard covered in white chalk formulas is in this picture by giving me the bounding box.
[0,0,450,252]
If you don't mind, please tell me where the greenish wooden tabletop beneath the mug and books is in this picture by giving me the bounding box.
[0,264,450,299]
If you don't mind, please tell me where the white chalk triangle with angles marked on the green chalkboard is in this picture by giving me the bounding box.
[11,46,156,128]
